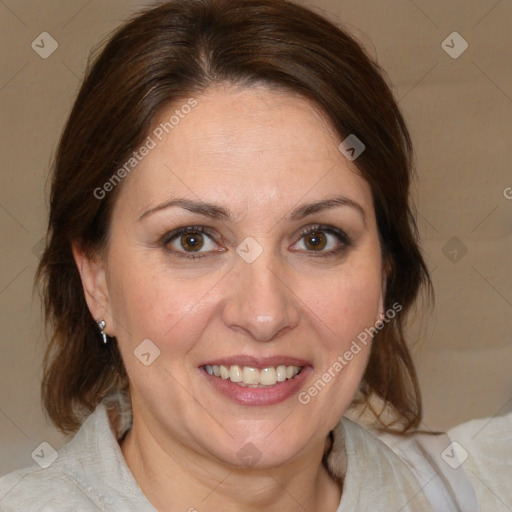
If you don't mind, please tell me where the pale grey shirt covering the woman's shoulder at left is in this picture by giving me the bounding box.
[0,404,142,512]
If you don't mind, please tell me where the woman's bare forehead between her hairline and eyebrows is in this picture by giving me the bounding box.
[116,86,371,218]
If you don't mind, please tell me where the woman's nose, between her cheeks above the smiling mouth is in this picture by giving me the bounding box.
[222,252,300,341]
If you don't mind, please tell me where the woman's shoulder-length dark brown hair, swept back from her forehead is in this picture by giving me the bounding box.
[36,0,431,432]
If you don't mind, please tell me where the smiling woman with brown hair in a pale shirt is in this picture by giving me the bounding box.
[0,0,510,512]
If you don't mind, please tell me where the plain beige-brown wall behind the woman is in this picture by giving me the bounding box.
[0,0,512,474]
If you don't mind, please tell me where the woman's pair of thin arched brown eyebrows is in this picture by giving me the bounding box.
[138,196,366,224]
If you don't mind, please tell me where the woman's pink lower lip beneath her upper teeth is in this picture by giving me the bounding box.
[200,366,312,405]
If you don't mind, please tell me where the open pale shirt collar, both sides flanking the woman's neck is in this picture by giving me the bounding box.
[63,394,432,512]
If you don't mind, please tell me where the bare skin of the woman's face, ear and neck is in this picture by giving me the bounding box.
[74,86,383,512]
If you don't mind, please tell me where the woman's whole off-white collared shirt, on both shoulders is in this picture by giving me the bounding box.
[0,404,512,512]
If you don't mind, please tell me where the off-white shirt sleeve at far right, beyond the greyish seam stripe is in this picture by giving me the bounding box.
[448,412,512,512]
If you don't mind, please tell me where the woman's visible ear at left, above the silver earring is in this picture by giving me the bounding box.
[71,242,115,336]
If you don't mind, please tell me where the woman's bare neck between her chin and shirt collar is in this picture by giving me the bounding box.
[121,418,341,512]
